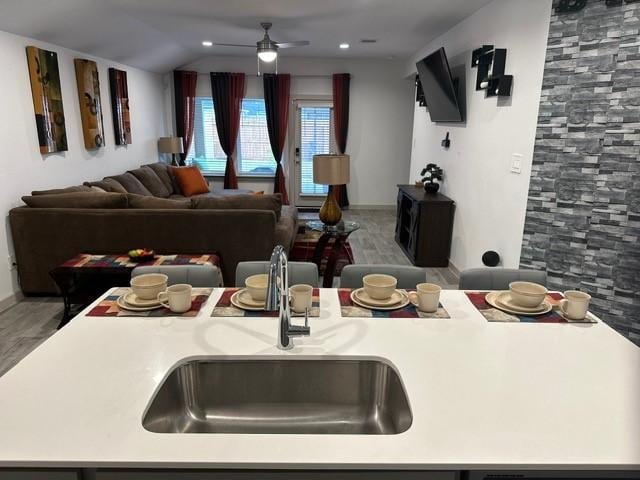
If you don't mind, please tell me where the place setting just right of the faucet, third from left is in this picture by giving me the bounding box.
[338,274,450,318]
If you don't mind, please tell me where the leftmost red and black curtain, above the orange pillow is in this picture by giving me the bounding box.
[173,70,198,165]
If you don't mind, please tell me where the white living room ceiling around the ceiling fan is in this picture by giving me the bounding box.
[0,0,491,72]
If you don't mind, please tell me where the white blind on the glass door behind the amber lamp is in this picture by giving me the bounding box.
[298,103,335,195]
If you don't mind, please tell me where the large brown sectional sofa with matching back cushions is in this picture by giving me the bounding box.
[9,163,298,295]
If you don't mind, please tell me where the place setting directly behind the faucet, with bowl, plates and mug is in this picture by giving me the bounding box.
[211,273,320,317]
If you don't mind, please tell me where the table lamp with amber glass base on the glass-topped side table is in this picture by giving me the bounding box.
[313,154,350,226]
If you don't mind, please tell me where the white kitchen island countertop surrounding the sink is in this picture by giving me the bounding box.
[0,289,640,470]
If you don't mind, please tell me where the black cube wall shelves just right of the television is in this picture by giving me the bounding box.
[471,45,513,98]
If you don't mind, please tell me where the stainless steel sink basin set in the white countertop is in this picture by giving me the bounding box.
[143,359,413,435]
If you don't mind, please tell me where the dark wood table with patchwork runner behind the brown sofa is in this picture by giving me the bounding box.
[49,253,221,328]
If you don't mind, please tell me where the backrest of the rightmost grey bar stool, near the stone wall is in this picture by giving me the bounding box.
[458,268,547,290]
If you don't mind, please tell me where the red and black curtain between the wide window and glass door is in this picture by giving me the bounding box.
[263,73,291,205]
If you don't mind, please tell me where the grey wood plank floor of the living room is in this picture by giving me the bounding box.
[0,210,458,376]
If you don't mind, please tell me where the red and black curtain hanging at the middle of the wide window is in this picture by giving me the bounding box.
[211,72,245,188]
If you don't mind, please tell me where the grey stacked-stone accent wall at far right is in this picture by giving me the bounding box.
[520,0,640,344]
